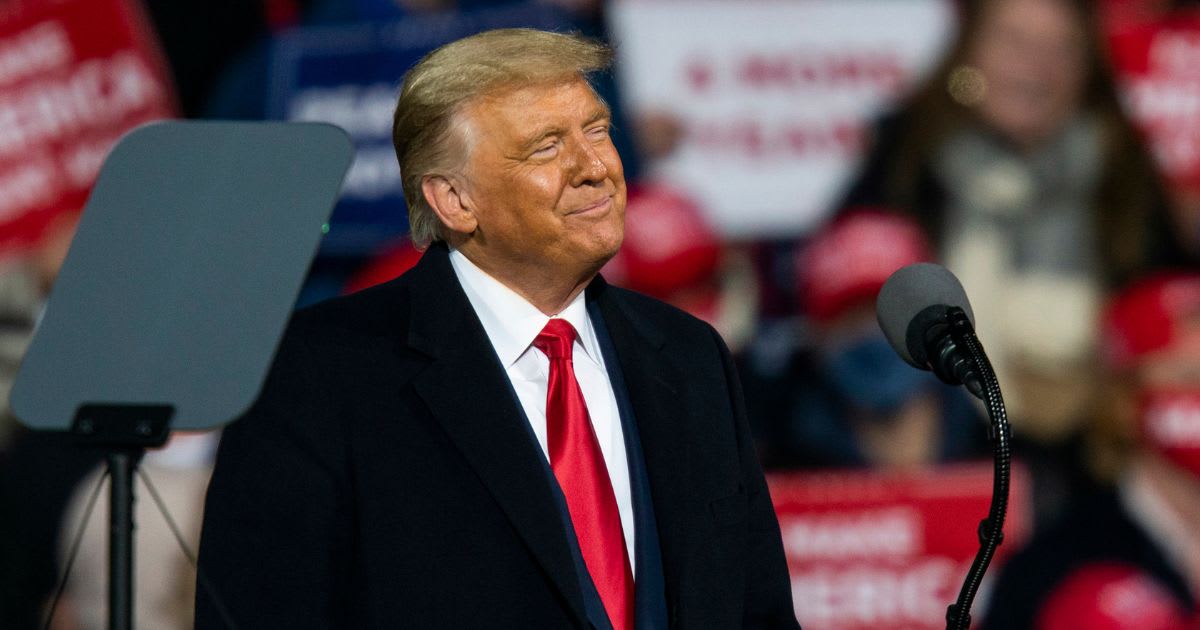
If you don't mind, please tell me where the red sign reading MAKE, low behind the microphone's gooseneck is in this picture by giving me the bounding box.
[768,463,1031,630]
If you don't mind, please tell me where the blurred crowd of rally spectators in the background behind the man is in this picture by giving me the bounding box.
[0,0,1200,629]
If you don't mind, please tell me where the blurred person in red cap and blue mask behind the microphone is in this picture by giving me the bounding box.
[746,209,989,469]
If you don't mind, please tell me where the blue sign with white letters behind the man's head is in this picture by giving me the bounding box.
[266,4,570,256]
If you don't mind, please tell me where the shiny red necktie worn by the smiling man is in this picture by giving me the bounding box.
[533,319,634,630]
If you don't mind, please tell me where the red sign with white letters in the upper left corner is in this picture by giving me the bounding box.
[0,0,175,257]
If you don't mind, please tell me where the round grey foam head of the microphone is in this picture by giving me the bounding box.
[875,263,974,370]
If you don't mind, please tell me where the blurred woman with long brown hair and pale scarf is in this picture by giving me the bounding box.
[846,0,1188,443]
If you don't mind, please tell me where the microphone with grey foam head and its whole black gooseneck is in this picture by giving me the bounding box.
[876,263,1012,630]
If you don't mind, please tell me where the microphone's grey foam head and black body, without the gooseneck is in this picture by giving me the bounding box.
[875,263,984,400]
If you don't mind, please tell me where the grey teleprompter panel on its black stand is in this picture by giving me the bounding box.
[11,121,353,630]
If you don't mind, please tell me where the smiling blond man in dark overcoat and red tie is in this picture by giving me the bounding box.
[197,30,797,630]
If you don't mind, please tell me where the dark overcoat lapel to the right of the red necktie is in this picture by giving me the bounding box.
[588,278,702,617]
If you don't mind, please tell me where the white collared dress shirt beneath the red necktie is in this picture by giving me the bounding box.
[450,250,635,569]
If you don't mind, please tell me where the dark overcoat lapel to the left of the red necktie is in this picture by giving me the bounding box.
[407,245,586,623]
